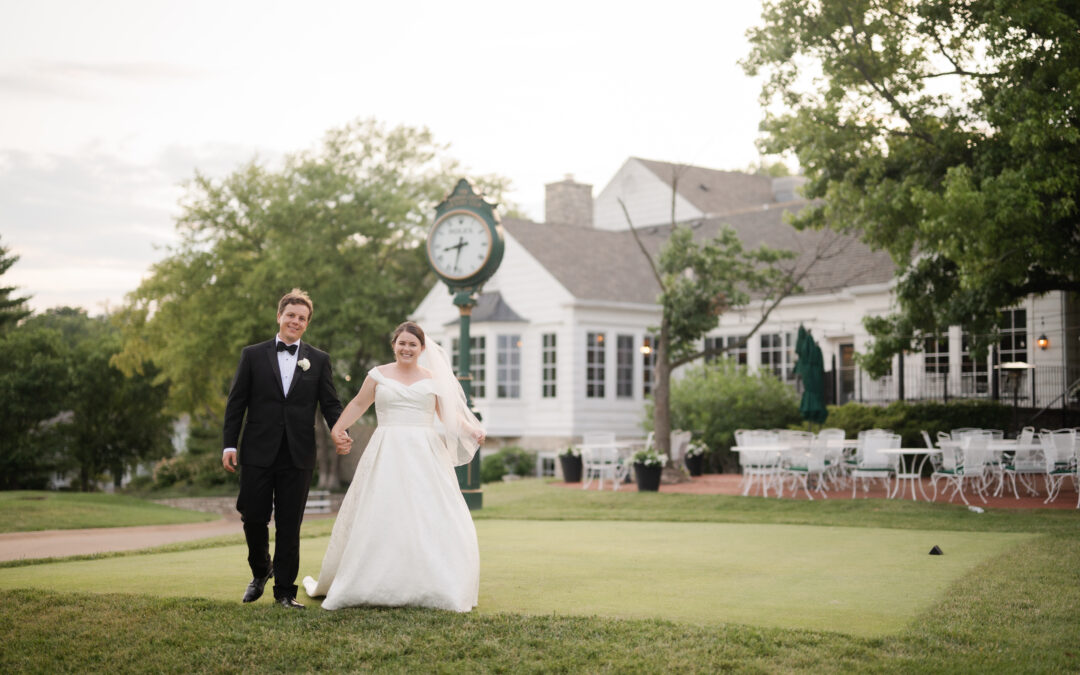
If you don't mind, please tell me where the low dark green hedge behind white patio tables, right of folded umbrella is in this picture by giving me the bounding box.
[825,401,1016,447]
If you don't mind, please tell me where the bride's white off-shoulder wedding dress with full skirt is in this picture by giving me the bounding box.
[303,368,480,611]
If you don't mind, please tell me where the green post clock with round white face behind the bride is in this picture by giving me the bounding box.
[428,178,504,509]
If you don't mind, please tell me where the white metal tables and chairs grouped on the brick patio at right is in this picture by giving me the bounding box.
[731,427,1080,509]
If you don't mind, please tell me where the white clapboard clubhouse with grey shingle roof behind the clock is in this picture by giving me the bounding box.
[413,158,1080,449]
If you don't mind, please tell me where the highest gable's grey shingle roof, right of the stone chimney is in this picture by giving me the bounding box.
[632,158,775,216]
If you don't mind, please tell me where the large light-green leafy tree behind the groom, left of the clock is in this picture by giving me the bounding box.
[118,120,505,487]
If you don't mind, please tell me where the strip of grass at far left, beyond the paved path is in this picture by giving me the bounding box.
[0,490,220,532]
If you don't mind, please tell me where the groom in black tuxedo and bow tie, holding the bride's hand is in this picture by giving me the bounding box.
[221,288,341,609]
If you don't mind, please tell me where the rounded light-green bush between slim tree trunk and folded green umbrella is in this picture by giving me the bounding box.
[646,359,801,471]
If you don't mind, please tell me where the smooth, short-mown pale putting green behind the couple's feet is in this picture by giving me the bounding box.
[0,521,1032,636]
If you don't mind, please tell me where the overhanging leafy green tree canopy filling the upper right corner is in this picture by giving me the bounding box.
[743,0,1080,375]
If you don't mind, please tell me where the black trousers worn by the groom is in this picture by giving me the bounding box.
[237,436,312,598]
